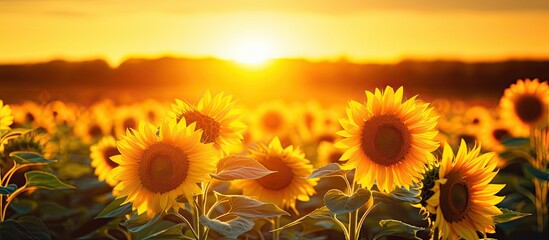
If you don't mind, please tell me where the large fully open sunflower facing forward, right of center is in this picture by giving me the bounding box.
[336,87,439,192]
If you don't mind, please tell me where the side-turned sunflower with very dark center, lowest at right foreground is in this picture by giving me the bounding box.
[427,141,505,239]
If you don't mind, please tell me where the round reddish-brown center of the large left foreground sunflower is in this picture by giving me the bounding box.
[139,142,189,193]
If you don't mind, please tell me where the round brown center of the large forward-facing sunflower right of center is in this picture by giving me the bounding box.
[361,115,412,166]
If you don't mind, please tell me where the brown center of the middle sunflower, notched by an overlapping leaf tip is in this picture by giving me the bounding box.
[256,156,294,190]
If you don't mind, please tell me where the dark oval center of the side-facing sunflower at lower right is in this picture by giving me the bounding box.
[440,173,470,222]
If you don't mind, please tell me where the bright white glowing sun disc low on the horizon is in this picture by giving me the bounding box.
[228,37,274,65]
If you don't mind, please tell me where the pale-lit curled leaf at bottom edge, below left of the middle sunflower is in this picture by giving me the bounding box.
[200,215,254,239]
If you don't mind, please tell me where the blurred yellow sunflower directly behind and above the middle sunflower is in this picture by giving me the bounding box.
[250,101,294,142]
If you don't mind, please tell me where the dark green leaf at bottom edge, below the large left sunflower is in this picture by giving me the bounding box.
[135,220,185,240]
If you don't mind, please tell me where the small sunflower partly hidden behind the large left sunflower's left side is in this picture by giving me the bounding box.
[90,136,120,187]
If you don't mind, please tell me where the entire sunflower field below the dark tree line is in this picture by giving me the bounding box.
[0,79,549,240]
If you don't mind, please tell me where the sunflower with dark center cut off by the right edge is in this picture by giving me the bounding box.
[500,79,549,137]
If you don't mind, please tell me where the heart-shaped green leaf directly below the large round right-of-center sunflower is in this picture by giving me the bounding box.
[324,188,372,214]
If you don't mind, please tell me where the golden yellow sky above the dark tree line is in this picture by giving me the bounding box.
[0,0,549,64]
